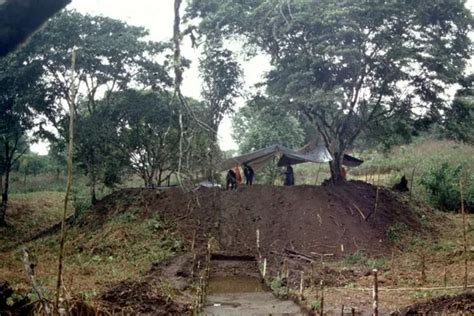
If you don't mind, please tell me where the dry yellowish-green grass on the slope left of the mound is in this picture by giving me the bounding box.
[0,188,183,299]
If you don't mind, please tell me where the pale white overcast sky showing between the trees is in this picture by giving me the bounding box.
[30,0,474,154]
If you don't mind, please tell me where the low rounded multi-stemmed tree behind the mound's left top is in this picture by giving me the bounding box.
[114,90,179,188]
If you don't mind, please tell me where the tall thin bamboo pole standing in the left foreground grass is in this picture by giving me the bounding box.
[54,50,76,313]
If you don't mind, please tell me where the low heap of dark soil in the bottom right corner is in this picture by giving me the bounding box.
[392,292,474,316]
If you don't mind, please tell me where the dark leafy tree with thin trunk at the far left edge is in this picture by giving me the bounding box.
[0,52,51,226]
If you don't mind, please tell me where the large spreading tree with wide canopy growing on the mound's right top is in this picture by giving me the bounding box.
[189,0,473,183]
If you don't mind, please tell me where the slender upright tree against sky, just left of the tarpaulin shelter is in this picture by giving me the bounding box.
[199,34,242,181]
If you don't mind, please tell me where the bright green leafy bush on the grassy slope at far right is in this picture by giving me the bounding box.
[421,162,468,211]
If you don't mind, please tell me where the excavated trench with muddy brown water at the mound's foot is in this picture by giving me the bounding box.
[203,261,303,316]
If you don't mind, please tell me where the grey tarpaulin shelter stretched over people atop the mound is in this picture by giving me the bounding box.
[218,143,363,170]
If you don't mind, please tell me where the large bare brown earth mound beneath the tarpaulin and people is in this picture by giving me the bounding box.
[144,181,426,257]
